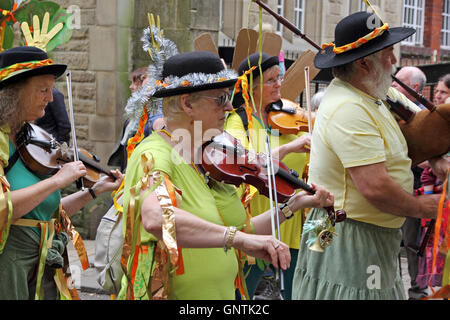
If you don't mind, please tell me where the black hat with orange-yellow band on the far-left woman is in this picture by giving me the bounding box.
[0,47,67,90]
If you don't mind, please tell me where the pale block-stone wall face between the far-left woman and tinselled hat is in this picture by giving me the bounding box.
[51,0,134,164]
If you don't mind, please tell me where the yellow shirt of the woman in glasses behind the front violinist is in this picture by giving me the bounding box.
[225,112,307,249]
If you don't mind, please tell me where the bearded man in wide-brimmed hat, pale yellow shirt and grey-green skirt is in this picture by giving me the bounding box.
[293,12,448,300]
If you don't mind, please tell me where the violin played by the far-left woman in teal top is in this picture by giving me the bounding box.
[16,123,116,188]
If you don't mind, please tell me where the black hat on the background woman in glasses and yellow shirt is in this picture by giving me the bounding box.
[233,52,279,108]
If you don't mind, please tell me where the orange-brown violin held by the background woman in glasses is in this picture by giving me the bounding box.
[267,99,315,134]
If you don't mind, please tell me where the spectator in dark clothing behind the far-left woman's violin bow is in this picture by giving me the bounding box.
[34,88,70,144]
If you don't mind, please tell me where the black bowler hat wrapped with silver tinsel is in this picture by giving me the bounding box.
[153,51,237,98]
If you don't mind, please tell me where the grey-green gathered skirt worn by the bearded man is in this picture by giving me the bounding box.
[292,209,406,300]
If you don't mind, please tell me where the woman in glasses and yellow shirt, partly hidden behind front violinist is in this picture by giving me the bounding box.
[225,52,311,300]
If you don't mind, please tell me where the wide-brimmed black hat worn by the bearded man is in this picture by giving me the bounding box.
[314,11,416,69]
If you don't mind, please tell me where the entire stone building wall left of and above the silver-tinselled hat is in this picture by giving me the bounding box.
[44,0,219,165]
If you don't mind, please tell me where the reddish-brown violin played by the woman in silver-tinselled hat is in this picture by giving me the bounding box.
[201,132,346,225]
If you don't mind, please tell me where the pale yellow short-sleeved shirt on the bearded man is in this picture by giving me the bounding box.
[309,79,418,228]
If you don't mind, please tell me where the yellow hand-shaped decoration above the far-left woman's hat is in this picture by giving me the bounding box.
[21,12,63,51]
